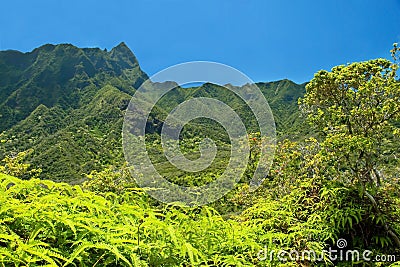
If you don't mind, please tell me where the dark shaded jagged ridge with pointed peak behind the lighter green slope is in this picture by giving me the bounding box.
[0,43,147,131]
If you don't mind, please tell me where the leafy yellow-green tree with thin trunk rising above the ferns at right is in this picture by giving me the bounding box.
[299,46,400,247]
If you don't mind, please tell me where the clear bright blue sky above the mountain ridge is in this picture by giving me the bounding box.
[0,0,400,83]
